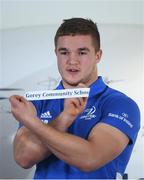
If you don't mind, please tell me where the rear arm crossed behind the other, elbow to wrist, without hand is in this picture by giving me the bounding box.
[13,105,77,168]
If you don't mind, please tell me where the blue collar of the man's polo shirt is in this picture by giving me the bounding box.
[56,76,107,97]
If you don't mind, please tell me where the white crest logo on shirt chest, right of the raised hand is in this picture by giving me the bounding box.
[80,106,96,120]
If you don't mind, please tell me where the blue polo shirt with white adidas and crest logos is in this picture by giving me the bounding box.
[33,77,140,179]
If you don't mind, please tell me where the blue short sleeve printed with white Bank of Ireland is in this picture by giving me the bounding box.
[101,94,140,143]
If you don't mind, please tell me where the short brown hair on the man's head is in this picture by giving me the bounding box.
[54,18,100,51]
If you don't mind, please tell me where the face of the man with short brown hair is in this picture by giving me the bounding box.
[55,35,101,88]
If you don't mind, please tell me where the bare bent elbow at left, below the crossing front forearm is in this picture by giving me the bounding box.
[13,126,51,168]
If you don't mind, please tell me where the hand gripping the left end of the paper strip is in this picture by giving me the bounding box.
[9,95,37,123]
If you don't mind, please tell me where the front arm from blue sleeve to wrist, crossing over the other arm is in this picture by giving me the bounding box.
[20,116,129,171]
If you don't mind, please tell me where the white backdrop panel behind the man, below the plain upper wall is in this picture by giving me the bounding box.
[0,24,144,178]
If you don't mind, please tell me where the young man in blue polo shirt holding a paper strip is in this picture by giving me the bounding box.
[10,18,140,179]
